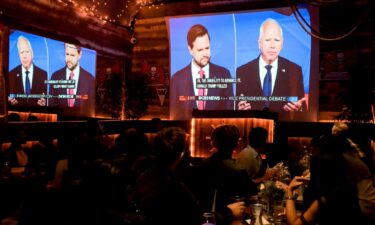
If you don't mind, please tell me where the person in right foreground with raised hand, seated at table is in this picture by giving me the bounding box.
[286,135,375,225]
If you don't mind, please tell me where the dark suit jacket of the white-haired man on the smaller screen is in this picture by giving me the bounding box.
[9,64,47,106]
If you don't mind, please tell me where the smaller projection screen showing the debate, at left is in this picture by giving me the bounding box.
[7,30,96,116]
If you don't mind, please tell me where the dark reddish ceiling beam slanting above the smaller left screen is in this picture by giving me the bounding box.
[0,0,133,57]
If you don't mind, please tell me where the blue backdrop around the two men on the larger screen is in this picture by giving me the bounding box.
[168,8,318,121]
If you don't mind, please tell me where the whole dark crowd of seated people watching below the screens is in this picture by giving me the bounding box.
[0,122,375,225]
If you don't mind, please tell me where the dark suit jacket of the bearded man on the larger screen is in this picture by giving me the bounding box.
[169,63,234,120]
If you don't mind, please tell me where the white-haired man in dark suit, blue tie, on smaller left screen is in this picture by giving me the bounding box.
[8,36,47,107]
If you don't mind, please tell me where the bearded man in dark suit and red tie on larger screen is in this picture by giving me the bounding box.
[169,24,234,120]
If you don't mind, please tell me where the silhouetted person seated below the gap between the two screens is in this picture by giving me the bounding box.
[81,128,151,224]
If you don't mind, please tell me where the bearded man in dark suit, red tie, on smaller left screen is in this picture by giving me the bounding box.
[49,43,95,115]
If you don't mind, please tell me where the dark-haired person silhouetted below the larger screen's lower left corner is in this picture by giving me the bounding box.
[130,127,203,225]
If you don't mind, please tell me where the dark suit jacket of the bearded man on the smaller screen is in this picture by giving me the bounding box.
[49,67,95,115]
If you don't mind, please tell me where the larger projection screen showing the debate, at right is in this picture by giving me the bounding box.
[167,7,318,121]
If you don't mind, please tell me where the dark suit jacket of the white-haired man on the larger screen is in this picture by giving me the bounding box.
[236,56,306,112]
